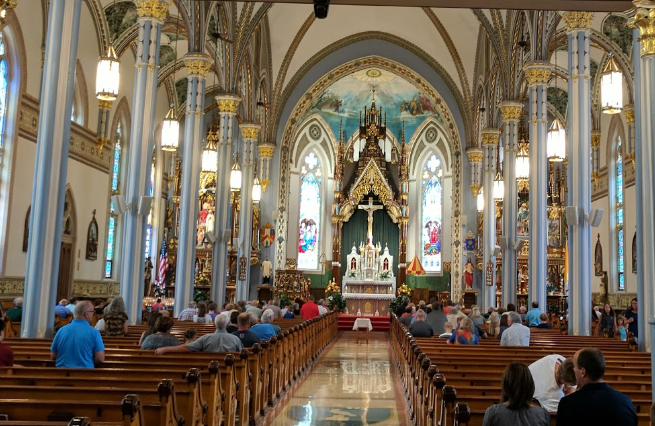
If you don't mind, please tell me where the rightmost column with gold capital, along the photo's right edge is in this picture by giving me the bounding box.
[632,0,655,354]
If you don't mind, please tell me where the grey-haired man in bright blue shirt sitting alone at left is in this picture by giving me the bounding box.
[50,300,105,368]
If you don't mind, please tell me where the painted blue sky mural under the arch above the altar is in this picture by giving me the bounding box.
[306,68,445,139]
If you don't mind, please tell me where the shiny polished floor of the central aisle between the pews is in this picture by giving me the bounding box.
[271,332,408,426]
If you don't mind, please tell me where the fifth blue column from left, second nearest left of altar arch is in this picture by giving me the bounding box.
[235,123,261,301]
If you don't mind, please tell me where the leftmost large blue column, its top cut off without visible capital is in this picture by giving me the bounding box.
[21,0,82,338]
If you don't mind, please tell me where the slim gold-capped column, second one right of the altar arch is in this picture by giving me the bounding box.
[481,129,500,312]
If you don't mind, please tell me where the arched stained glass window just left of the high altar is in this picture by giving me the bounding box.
[298,151,323,270]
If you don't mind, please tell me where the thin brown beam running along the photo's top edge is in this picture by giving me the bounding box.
[218,0,633,12]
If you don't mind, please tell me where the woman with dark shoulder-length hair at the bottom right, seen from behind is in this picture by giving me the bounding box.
[482,362,550,426]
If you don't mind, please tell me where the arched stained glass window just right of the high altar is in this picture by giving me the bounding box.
[421,154,443,272]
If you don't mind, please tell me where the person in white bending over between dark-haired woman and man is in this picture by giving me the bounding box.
[528,354,577,413]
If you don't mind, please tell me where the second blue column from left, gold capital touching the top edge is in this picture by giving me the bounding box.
[119,0,168,325]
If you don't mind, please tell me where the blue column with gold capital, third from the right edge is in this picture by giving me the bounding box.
[524,62,551,310]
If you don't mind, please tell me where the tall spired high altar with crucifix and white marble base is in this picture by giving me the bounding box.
[332,90,409,316]
